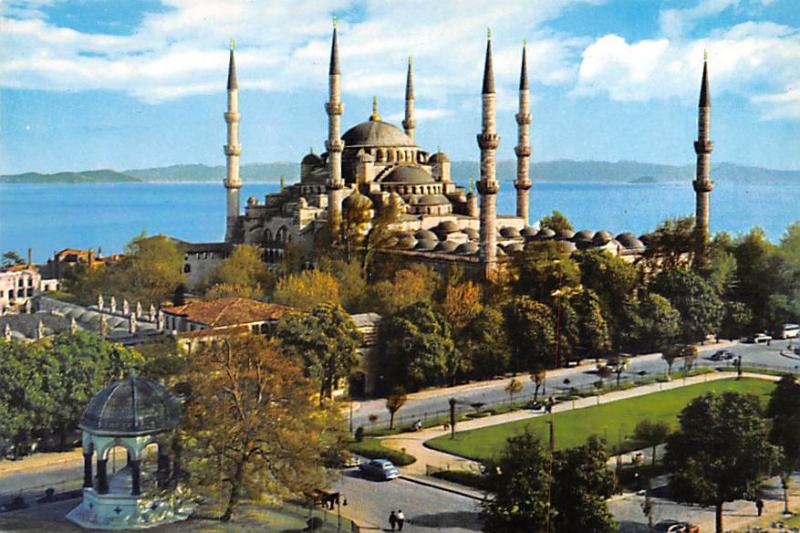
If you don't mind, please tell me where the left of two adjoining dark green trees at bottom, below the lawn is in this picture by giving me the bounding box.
[481,432,554,533]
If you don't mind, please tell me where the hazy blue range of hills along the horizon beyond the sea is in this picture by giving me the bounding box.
[6,160,800,185]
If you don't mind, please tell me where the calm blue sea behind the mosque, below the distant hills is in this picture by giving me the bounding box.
[0,182,800,262]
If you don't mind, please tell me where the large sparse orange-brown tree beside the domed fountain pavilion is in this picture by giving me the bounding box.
[180,335,346,522]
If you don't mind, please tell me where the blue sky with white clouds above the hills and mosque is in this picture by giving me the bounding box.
[0,0,800,174]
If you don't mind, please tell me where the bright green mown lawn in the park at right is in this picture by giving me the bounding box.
[425,379,774,461]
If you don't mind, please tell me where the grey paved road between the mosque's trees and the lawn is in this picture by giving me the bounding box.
[353,340,800,428]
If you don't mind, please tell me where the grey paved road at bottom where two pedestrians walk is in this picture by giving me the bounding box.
[334,469,481,533]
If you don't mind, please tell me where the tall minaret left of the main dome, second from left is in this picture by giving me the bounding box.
[325,18,344,231]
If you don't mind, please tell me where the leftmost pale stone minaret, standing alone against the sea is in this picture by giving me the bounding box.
[223,39,242,242]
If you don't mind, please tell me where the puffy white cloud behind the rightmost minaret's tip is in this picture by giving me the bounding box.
[574,22,800,119]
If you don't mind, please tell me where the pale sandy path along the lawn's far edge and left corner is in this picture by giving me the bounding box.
[381,372,780,475]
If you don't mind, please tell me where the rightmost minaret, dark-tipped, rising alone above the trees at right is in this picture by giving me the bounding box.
[692,54,714,261]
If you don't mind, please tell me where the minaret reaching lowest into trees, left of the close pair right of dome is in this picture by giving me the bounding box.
[478,30,500,279]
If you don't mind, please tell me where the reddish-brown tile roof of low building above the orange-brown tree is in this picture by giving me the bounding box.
[163,298,298,328]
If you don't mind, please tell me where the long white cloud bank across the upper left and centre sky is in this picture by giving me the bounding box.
[0,0,603,103]
